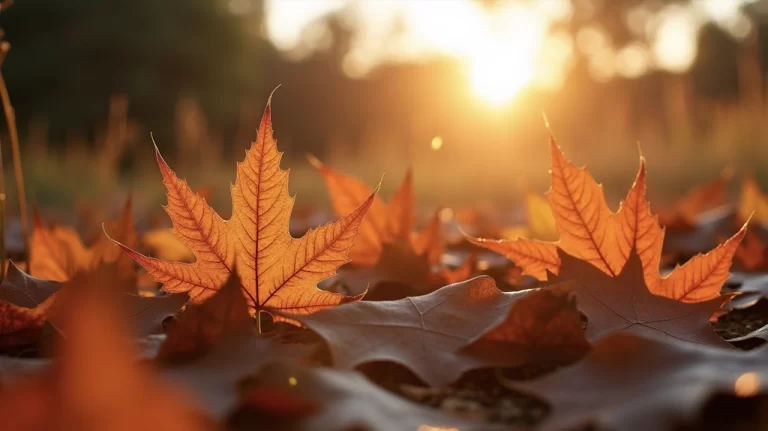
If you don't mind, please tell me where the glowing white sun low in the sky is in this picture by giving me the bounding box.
[466,7,543,105]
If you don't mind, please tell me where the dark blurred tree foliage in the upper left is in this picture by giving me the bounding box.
[0,0,275,145]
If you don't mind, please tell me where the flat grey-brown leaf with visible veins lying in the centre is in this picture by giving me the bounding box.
[287,277,525,386]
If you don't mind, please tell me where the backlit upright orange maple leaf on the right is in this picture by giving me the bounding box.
[468,137,746,302]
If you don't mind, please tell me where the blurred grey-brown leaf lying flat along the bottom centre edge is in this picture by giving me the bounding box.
[238,365,506,431]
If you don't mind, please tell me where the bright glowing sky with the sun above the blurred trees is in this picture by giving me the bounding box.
[258,0,751,103]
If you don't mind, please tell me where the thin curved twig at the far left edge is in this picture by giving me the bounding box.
[0,41,29,268]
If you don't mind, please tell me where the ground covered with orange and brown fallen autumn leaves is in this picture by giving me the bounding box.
[0,98,768,431]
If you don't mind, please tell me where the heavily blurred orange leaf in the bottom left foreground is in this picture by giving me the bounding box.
[0,260,215,431]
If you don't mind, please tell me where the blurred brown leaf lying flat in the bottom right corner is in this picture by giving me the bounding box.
[512,333,768,431]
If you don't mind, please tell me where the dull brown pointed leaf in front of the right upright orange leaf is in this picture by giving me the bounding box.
[549,246,730,347]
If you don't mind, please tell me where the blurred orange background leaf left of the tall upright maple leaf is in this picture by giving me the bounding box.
[29,198,136,291]
